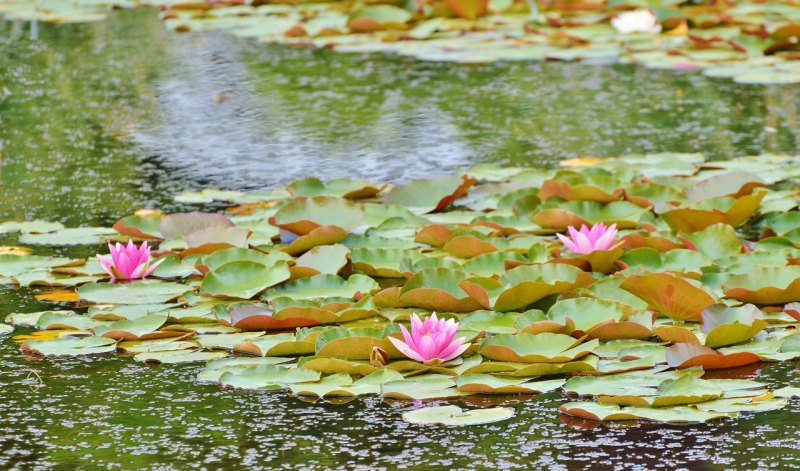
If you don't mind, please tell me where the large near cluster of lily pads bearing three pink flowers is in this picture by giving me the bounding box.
[0,154,800,423]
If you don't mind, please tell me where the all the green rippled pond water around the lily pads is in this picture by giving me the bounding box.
[0,10,800,469]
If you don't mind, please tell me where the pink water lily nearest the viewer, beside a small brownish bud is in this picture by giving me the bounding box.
[389,312,470,365]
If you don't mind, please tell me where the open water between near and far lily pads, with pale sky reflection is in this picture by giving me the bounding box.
[0,10,800,229]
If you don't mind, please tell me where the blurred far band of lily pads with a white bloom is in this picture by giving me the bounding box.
[0,0,800,83]
